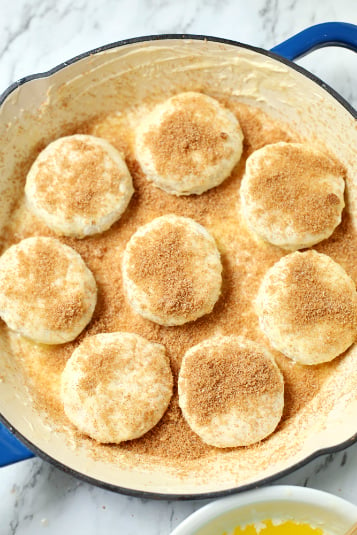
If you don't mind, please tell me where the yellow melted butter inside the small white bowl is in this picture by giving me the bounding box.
[222,519,327,535]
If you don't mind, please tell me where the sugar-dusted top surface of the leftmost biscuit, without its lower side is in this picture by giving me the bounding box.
[0,237,96,331]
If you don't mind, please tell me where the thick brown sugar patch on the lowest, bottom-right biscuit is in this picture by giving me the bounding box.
[182,340,282,425]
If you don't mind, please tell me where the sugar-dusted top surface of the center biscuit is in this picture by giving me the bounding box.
[124,214,221,319]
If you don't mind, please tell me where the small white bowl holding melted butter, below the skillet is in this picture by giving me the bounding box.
[171,486,357,535]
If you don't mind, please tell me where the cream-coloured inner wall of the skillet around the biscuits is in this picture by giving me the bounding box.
[0,38,357,497]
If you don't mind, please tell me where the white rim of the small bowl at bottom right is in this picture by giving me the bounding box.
[171,485,357,535]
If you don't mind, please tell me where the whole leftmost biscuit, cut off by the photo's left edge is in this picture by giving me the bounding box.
[0,237,97,344]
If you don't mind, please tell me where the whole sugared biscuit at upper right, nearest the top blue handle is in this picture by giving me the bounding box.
[240,142,345,251]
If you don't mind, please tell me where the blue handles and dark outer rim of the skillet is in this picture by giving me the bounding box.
[0,22,357,500]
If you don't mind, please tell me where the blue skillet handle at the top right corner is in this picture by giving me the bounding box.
[271,22,357,61]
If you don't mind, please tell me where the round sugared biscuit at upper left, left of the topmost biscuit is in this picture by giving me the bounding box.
[25,134,134,238]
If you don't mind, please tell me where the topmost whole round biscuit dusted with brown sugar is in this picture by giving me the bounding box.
[135,91,243,195]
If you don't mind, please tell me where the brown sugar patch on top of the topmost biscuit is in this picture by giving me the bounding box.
[145,99,231,177]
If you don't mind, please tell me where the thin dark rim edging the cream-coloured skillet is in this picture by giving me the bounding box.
[0,34,357,500]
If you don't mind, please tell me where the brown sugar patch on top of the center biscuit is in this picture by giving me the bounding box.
[128,222,205,316]
